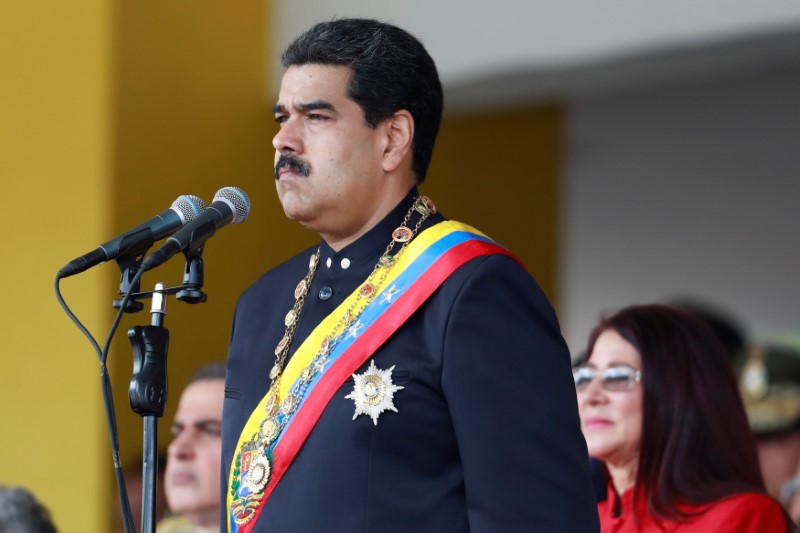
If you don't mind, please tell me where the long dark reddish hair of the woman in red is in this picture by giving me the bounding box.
[586,305,765,520]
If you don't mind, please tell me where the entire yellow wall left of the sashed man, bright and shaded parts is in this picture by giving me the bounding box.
[0,0,315,533]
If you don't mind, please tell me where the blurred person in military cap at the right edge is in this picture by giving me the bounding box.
[738,344,800,523]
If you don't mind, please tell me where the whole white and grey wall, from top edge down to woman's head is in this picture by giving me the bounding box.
[268,4,800,351]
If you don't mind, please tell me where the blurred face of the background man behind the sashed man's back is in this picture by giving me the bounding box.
[164,379,225,525]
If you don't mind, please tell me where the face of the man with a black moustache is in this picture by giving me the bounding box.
[272,64,393,245]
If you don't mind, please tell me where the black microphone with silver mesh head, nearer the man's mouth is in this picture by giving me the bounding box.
[141,187,250,271]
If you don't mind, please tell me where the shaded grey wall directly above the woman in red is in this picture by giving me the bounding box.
[559,62,800,351]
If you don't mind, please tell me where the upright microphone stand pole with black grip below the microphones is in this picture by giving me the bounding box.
[128,283,169,533]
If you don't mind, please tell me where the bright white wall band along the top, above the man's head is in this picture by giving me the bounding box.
[271,0,800,85]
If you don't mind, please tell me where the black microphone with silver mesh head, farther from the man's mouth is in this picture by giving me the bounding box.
[58,194,206,278]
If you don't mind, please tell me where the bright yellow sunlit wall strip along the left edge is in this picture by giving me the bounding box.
[0,0,111,532]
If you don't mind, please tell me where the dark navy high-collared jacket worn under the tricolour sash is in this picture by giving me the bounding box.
[222,191,599,533]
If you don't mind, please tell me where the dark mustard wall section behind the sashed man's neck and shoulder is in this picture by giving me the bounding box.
[421,105,562,303]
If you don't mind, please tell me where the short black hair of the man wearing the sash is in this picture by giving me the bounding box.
[281,18,444,183]
